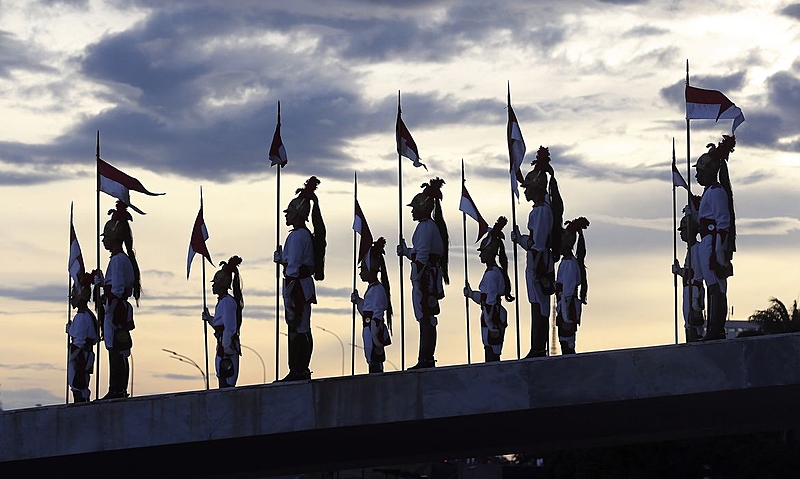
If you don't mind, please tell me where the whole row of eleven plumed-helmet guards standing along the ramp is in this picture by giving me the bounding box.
[67,136,735,403]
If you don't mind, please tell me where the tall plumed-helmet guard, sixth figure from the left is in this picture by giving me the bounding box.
[397,178,450,369]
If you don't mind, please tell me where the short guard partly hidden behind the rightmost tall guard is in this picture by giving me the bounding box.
[672,201,706,343]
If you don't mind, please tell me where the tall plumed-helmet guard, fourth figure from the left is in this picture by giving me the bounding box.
[273,176,326,381]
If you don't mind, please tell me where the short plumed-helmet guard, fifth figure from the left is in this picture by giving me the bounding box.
[350,237,392,374]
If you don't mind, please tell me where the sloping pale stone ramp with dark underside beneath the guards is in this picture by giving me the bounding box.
[0,334,800,477]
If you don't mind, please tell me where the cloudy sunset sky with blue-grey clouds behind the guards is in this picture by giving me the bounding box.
[0,0,800,409]
